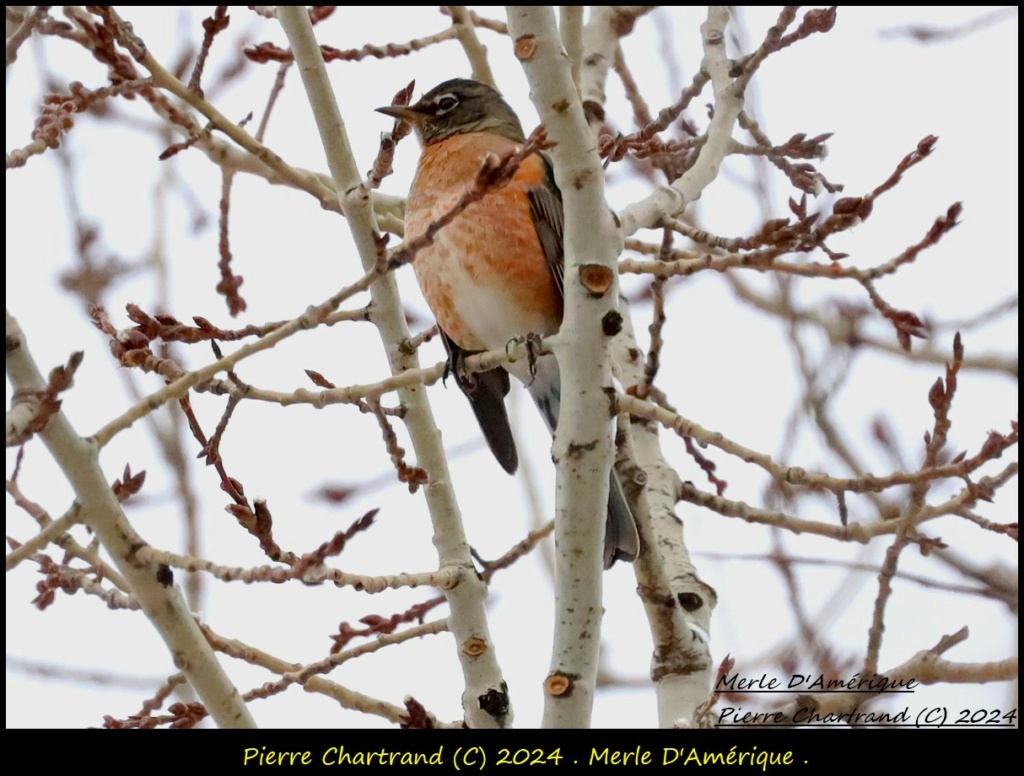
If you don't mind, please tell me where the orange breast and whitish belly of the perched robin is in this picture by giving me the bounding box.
[406,132,562,350]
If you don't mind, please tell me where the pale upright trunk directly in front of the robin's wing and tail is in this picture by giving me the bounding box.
[507,6,622,727]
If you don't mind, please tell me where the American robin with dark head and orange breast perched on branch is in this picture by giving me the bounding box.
[377,79,639,567]
